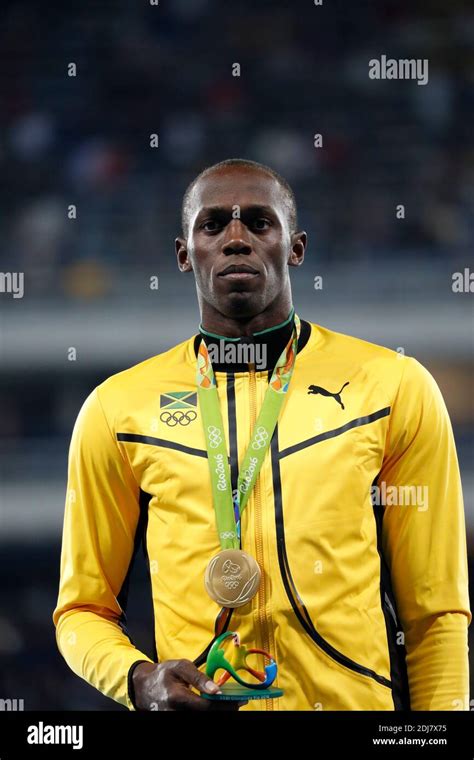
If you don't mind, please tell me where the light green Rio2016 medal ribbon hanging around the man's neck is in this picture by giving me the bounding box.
[196,314,301,549]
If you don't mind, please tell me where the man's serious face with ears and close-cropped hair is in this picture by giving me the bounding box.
[176,166,306,318]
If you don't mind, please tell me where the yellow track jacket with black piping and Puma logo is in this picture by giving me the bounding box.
[53,320,471,710]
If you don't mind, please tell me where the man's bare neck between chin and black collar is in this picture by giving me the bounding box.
[200,299,294,338]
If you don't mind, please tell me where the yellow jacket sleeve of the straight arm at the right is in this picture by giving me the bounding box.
[378,357,471,710]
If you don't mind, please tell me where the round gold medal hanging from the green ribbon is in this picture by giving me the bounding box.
[204,549,261,607]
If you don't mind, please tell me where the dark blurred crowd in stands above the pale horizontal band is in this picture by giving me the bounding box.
[0,0,474,299]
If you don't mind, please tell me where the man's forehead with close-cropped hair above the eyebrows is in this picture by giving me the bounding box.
[190,167,285,219]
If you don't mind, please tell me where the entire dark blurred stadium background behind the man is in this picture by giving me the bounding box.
[0,0,474,709]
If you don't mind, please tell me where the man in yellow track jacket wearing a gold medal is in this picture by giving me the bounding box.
[53,159,471,710]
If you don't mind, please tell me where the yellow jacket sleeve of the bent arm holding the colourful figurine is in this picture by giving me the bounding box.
[53,388,151,710]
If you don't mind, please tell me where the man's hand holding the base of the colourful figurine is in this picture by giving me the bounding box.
[132,660,248,711]
